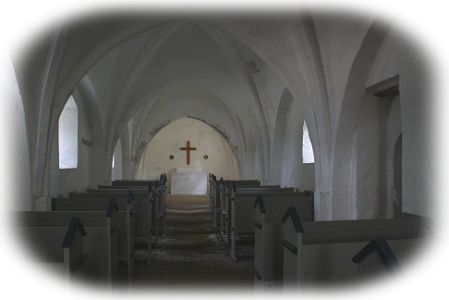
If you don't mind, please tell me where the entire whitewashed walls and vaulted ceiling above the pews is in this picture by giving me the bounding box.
[0,0,449,299]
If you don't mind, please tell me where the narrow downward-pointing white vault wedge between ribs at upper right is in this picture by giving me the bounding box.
[309,0,385,127]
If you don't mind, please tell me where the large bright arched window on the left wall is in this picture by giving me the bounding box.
[58,96,78,169]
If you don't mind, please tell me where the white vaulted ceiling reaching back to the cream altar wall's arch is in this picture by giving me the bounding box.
[69,16,285,180]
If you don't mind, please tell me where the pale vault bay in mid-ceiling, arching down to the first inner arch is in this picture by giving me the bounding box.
[75,22,292,180]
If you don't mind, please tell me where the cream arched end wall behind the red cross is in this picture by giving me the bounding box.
[136,118,240,192]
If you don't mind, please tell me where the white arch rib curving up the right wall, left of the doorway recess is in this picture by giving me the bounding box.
[327,0,409,219]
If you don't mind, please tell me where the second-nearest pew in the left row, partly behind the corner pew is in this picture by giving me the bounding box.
[0,199,120,300]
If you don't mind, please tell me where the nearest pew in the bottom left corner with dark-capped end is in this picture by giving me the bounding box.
[0,218,87,300]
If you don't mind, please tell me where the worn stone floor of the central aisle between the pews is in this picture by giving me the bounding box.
[86,195,282,300]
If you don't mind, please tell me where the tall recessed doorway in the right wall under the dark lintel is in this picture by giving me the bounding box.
[350,94,402,219]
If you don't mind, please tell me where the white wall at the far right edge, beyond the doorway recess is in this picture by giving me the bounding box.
[369,0,449,236]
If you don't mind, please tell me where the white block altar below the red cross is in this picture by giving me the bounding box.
[171,168,207,195]
